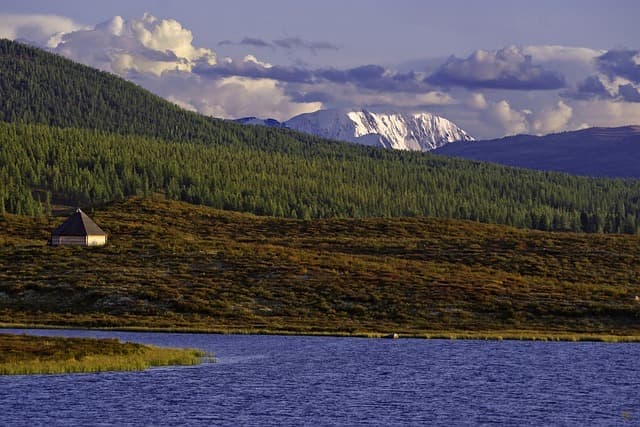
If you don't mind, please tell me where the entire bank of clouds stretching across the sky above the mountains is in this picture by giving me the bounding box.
[0,14,640,137]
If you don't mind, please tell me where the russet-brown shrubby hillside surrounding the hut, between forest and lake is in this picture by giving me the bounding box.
[0,197,640,335]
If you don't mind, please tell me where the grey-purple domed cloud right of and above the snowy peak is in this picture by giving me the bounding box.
[427,46,566,90]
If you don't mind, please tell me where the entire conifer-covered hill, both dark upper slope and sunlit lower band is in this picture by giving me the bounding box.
[0,40,640,233]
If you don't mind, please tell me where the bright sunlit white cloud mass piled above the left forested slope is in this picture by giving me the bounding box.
[5,13,322,120]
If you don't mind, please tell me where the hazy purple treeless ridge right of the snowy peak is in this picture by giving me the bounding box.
[434,126,640,178]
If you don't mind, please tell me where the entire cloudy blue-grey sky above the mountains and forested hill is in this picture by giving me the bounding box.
[0,0,640,138]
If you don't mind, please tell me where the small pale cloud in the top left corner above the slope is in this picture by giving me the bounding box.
[0,14,82,47]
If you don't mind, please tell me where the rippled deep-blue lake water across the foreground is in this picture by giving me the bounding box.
[0,330,640,426]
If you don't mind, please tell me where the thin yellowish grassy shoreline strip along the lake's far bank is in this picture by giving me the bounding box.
[5,323,640,343]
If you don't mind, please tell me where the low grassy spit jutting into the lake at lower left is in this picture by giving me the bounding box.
[0,334,205,375]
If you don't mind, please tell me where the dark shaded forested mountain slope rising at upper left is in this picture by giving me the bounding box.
[0,39,340,151]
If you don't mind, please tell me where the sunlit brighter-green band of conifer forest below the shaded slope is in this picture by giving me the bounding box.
[6,123,640,233]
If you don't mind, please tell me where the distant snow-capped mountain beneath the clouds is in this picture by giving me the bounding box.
[237,110,474,151]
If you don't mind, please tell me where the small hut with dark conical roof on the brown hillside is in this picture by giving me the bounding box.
[50,209,107,246]
